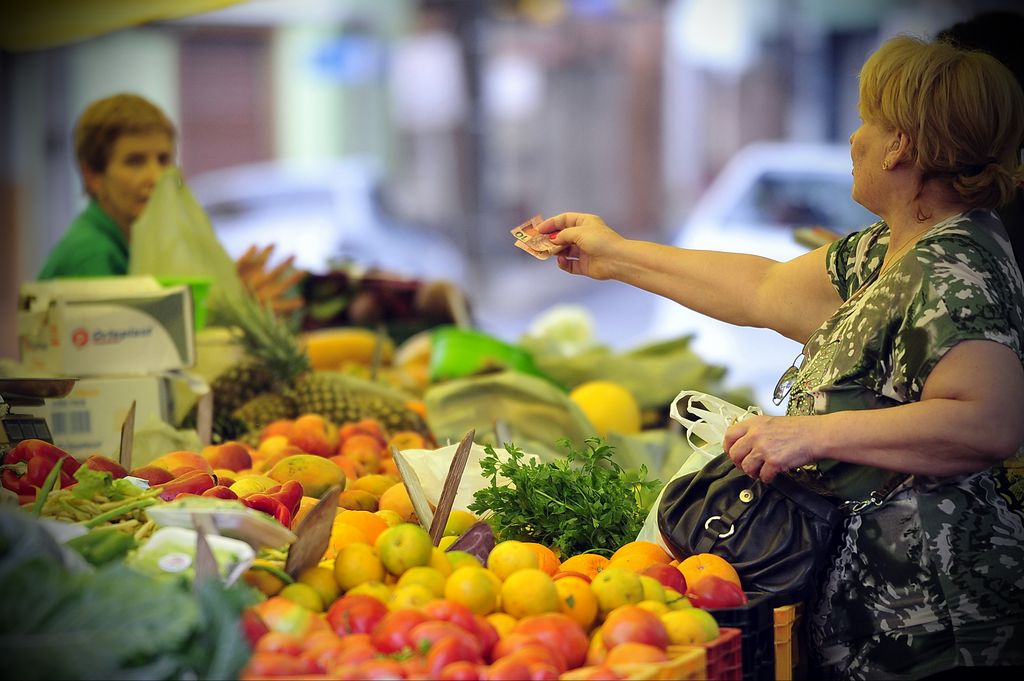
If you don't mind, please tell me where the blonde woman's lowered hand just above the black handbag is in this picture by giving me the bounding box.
[722,416,820,482]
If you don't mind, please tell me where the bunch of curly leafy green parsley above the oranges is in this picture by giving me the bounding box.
[469,438,662,556]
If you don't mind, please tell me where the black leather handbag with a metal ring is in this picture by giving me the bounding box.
[657,454,843,606]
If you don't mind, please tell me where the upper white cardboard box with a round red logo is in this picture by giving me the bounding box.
[17,276,196,377]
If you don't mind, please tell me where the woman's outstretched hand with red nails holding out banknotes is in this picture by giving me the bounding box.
[537,213,626,280]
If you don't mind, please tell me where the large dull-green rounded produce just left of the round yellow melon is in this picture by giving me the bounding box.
[423,371,597,462]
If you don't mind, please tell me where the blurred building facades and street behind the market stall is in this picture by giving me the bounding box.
[0,0,1020,382]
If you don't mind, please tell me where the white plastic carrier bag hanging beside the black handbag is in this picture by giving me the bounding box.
[637,390,762,553]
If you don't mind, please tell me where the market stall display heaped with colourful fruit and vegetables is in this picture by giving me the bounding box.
[0,270,800,679]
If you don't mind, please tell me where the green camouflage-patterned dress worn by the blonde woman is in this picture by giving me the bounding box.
[787,210,1024,679]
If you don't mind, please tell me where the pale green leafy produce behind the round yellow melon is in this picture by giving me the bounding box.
[519,336,753,409]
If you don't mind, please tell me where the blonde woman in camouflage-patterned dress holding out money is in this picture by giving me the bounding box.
[538,37,1024,679]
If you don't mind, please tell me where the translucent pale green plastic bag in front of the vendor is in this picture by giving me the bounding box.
[128,168,246,319]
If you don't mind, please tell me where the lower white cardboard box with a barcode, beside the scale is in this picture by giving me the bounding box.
[14,376,174,461]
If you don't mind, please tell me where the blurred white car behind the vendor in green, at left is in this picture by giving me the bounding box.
[188,157,466,284]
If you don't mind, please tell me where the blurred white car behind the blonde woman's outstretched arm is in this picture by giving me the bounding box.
[649,142,878,414]
